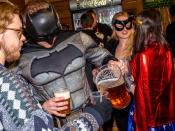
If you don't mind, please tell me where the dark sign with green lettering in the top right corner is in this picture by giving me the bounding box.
[143,0,173,9]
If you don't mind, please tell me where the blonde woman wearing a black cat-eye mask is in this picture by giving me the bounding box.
[105,12,135,131]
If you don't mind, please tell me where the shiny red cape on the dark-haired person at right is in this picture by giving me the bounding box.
[130,42,175,131]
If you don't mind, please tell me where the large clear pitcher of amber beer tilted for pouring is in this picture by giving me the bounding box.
[93,65,131,109]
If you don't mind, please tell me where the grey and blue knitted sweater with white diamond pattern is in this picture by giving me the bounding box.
[0,65,100,131]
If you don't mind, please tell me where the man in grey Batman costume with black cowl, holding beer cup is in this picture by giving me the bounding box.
[11,0,122,126]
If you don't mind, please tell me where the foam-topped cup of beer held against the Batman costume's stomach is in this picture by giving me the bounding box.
[54,89,70,114]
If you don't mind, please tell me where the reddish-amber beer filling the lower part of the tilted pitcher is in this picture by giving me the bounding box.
[107,84,131,110]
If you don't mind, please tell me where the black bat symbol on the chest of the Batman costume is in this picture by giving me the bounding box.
[31,44,83,77]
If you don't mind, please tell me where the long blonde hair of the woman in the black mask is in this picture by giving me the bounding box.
[109,12,135,59]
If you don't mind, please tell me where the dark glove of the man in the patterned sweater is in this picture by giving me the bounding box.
[85,99,112,125]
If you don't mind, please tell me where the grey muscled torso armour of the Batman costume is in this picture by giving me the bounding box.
[13,32,110,110]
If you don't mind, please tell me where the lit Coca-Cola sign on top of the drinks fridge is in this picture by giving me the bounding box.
[69,0,121,11]
